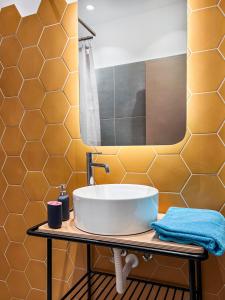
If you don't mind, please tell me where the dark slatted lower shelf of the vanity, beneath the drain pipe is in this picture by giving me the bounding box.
[61,272,190,300]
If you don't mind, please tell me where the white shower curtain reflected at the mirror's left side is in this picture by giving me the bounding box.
[79,41,101,145]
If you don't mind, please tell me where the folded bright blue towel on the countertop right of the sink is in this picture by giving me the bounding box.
[152,207,225,256]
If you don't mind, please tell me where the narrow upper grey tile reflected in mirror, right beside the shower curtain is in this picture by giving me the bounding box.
[96,67,114,119]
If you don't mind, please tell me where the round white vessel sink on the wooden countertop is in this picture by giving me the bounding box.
[73,184,158,235]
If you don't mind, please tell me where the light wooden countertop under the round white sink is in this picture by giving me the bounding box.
[38,213,204,254]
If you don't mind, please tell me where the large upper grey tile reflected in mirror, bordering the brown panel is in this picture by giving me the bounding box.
[115,62,145,118]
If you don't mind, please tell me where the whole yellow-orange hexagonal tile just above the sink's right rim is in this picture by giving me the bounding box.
[148,155,190,192]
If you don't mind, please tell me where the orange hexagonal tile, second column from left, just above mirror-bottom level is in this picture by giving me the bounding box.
[21,110,45,141]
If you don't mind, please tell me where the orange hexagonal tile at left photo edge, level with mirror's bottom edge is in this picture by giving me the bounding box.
[2,127,25,156]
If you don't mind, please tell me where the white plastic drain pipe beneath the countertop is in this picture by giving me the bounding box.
[113,248,139,294]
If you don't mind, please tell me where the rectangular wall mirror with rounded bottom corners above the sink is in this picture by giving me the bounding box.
[79,0,187,146]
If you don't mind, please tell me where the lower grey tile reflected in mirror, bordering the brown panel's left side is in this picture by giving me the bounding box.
[115,117,146,146]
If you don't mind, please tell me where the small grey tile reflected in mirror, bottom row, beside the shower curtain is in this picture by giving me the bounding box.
[101,119,115,146]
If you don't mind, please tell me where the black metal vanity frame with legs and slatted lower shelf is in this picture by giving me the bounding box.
[27,222,208,300]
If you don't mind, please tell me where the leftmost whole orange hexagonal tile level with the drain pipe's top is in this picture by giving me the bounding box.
[5,243,29,271]
